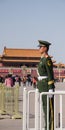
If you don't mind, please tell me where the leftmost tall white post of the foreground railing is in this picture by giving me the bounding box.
[23,88,27,130]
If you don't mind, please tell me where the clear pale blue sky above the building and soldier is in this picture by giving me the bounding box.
[0,0,65,64]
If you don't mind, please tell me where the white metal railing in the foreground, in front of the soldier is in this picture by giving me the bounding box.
[23,88,65,130]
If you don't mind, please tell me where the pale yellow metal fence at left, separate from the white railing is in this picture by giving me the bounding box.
[0,83,21,119]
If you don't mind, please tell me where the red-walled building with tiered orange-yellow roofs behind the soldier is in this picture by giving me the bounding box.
[0,47,65,80]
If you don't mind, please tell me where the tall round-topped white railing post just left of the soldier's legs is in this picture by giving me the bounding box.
[35,89,39,130]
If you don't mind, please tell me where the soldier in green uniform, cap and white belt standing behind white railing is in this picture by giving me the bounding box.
[37,40,55,130]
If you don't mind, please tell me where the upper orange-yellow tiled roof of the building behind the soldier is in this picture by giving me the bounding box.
[3,48,41,57]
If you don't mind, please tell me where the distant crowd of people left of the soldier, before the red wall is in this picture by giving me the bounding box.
[0,74,37,88]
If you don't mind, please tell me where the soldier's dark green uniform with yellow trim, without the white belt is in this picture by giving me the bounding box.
[38,41,54,130]
